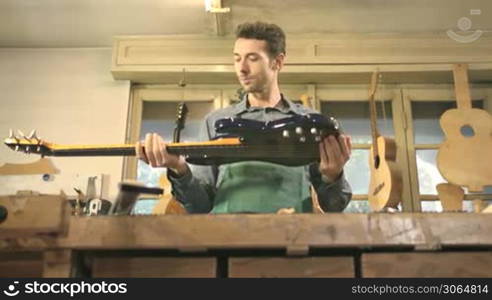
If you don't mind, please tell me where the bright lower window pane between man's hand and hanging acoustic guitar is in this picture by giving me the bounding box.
[344,149,370,195]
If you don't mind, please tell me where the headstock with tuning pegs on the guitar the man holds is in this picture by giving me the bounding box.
[4,130,53,156]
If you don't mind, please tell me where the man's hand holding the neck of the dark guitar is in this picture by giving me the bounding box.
[135,133,188,175]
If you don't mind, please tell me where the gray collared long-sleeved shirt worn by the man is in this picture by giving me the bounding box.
[167,95,352,213]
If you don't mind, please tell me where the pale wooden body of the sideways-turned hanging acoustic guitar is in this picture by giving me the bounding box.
[368,136,402,211]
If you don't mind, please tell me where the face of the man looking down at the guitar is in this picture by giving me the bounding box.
[234,38,279,93]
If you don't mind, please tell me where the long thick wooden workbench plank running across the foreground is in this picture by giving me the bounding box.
[0,213,492,251]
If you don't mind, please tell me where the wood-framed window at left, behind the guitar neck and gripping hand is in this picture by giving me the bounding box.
[124,85,221,214]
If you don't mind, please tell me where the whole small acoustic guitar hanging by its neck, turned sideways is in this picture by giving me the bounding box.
[368,71,402,211]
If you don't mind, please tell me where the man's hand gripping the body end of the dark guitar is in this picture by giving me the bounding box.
[319,134,352,182]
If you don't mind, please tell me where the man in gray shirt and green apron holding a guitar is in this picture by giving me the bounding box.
[136,22,352,213]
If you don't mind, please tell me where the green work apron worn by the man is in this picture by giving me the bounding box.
[211,161,312,214]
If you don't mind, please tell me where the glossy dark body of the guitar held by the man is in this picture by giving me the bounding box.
[183,114,340,166]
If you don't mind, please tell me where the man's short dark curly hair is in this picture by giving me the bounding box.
[236,22,285,58]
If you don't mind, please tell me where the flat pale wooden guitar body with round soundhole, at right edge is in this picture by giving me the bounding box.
[437,108,492,192]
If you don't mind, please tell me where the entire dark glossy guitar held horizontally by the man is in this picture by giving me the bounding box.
[4,114,339,166]
